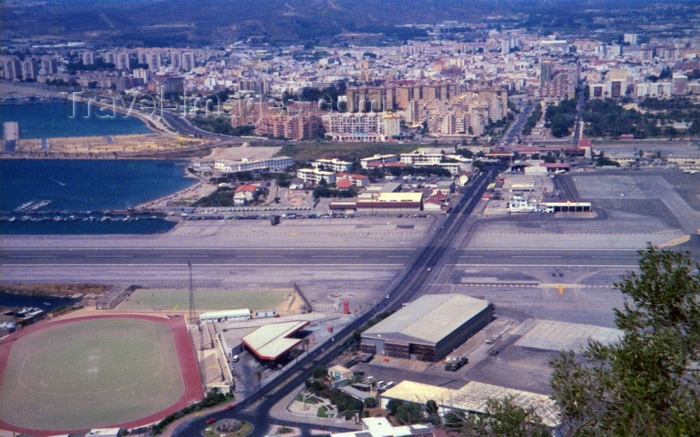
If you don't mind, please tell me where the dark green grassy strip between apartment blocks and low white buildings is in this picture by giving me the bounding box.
[256,141,429,161]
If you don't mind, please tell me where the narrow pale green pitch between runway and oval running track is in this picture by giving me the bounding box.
[117,288,292,311]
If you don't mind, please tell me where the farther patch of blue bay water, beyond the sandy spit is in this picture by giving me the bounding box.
[0,102,151,139]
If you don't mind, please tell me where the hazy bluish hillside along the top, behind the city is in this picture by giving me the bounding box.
[0,0,693,47]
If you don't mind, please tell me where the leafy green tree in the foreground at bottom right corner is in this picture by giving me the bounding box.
[551,245,700,436]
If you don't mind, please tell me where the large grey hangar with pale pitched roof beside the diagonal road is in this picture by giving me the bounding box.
[361,294,494,361]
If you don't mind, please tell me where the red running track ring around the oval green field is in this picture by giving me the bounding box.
[0,314,204,437]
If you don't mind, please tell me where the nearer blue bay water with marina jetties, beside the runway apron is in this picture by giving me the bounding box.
[0,159,195,234]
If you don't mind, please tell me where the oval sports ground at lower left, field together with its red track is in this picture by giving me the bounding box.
[0,317,201,434]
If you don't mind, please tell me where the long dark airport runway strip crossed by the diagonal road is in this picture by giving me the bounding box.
[0,248,639,268]
